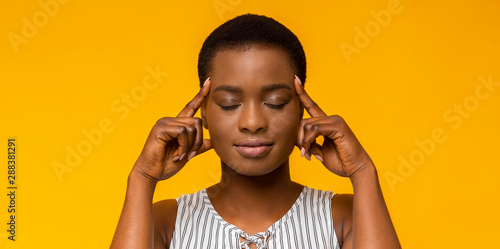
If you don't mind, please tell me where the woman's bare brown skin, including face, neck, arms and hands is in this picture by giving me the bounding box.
[111,44,400,248]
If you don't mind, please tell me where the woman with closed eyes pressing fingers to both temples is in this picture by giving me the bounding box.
[111,14,400,249]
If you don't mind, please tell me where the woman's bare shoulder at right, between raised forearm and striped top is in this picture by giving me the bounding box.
[332,194,353,247]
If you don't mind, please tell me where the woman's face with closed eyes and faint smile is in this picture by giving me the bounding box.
[202,45,301,176]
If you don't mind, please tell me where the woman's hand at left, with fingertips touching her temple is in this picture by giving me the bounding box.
[132,78,212,183]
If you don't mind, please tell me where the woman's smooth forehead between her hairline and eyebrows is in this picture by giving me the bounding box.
[209,45,295,90]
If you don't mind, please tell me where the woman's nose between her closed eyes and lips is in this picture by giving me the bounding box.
[239,103,268,133]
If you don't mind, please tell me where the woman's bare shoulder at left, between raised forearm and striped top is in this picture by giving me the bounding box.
[153,199,177,248]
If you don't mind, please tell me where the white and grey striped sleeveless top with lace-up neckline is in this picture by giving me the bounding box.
[169,187,340,249]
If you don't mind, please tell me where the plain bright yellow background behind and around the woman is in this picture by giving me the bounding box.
[0,0,500,249]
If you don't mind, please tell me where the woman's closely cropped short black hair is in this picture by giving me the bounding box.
[198,14,306,86]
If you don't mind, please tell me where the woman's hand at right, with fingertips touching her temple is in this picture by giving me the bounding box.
[295,76,373,177]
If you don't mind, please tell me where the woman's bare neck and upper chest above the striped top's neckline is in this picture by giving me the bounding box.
[207,159,303,234]
